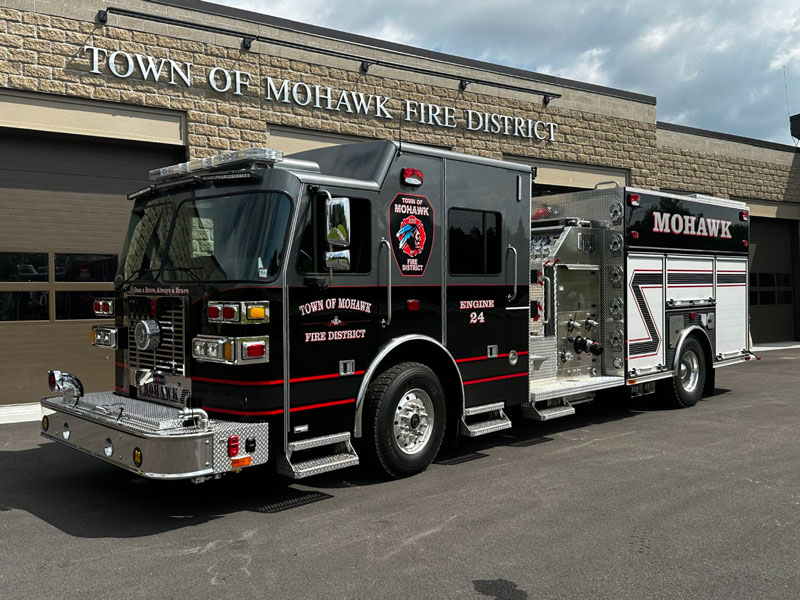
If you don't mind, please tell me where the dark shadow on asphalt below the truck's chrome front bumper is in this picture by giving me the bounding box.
[0,426,340,538]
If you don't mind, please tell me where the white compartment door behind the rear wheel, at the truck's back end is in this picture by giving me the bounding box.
[716,258,750,358]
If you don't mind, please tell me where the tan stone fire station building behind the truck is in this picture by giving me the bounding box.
[0,0,800,402]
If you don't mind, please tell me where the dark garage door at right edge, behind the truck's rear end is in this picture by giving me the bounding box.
[750,217,797,344]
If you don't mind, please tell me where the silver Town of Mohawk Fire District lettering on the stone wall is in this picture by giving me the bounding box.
[83,45,558,142]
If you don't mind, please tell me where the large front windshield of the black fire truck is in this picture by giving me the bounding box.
[117,192,291,281]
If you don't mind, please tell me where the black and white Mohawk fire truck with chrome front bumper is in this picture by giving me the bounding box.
[41,141,754,482]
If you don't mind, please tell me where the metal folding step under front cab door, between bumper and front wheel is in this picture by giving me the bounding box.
[278,431,358,479]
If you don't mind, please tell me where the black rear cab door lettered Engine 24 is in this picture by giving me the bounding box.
[444,160,529,407]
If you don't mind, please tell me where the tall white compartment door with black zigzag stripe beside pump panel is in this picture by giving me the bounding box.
[626,254,665,375]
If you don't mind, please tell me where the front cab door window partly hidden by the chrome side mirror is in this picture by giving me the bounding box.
[297,197,372,275]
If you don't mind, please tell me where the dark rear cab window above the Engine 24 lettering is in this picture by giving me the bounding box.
[447,208,502,275]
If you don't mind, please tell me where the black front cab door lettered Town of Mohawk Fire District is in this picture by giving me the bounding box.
[284,186,382,441]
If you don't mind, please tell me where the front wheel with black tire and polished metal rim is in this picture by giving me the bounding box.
[362,362,447,479]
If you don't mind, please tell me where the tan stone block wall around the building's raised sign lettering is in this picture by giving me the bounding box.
[0,0,658,187]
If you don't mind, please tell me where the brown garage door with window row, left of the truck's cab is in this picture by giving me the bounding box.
[0,129,185,404]
